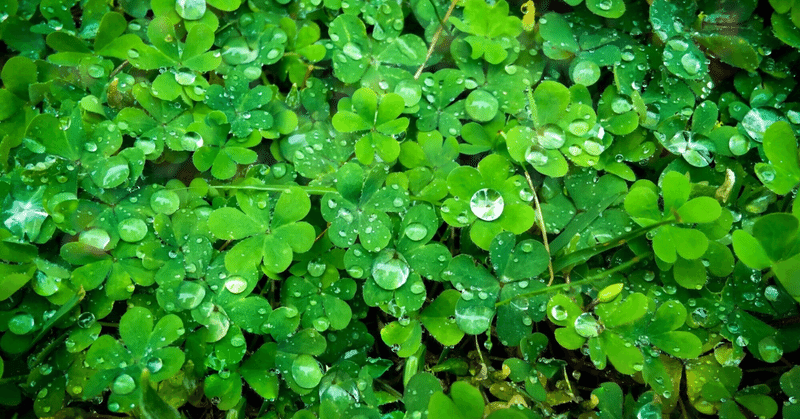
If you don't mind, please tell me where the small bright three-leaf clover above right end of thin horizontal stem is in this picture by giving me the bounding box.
[331,87,408,165]
